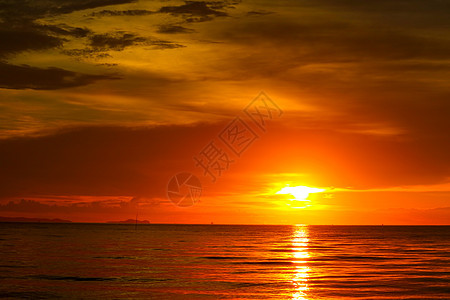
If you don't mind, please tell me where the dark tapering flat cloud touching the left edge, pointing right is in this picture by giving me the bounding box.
[0,62,118,90]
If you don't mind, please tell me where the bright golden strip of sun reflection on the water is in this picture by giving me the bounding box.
[292,225,310,300]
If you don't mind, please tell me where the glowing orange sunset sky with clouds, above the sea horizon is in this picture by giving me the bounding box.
[0,0,450,224]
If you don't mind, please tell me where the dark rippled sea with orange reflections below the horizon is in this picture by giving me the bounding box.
[0,223,450,299]
